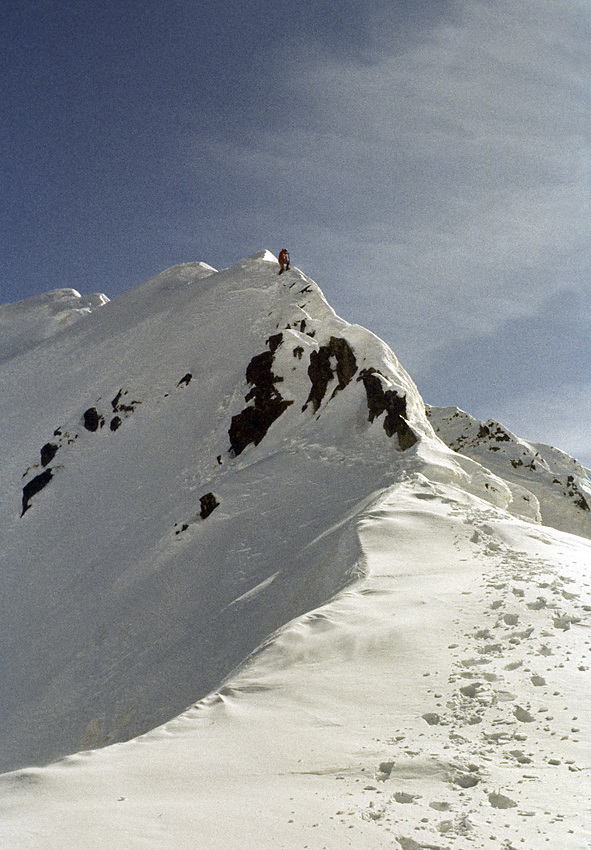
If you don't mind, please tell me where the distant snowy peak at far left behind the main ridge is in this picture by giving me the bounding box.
[0,289,109,360]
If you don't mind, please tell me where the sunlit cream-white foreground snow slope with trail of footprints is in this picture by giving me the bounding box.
[0,476,591,850]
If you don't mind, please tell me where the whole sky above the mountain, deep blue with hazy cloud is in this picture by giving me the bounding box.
[0,0,591,466]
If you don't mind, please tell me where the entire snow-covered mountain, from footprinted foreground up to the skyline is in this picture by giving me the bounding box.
[0,251,591,850]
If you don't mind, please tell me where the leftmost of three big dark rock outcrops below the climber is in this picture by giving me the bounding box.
[228,334,293,455]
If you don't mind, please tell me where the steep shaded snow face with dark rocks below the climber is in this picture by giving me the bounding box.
[0,252,456,769]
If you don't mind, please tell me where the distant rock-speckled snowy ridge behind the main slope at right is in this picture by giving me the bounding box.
[427,406,591,537]
